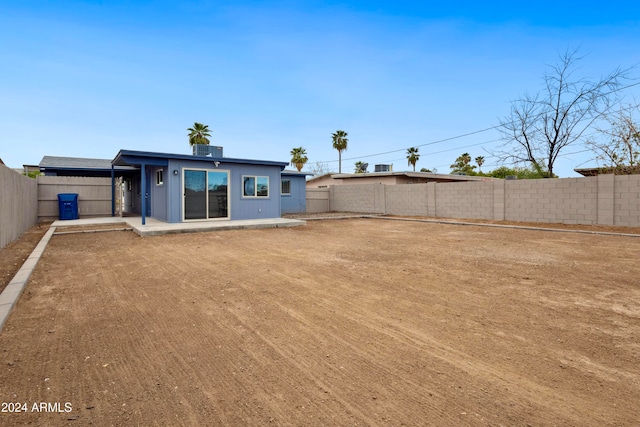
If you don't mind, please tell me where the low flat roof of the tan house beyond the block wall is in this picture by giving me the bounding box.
[307,171,496,185]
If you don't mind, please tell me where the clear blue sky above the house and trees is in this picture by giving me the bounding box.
[0,0,640,177]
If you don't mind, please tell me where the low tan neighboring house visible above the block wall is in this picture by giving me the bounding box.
[307,172,495,188]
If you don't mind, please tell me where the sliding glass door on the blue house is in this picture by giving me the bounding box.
[183,169,229,221]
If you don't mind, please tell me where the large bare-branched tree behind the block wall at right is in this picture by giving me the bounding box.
[495,50,630,176]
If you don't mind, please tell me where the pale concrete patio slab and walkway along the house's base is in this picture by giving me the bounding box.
[52,217,306,236]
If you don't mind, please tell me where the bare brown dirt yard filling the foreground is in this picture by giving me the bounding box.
[0,219,640,426]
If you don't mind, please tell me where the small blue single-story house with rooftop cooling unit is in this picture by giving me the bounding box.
[111,146,306,224]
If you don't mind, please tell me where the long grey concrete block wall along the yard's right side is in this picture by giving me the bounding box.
[307,175,640,227]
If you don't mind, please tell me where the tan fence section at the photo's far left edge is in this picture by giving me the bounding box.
[0,164,38,249]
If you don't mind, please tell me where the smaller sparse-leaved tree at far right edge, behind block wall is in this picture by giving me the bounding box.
[587,105,640,175]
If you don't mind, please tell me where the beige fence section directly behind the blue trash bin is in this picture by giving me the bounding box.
[38,176,111,221]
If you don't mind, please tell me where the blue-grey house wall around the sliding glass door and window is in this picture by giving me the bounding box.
[164,159,281,222]
